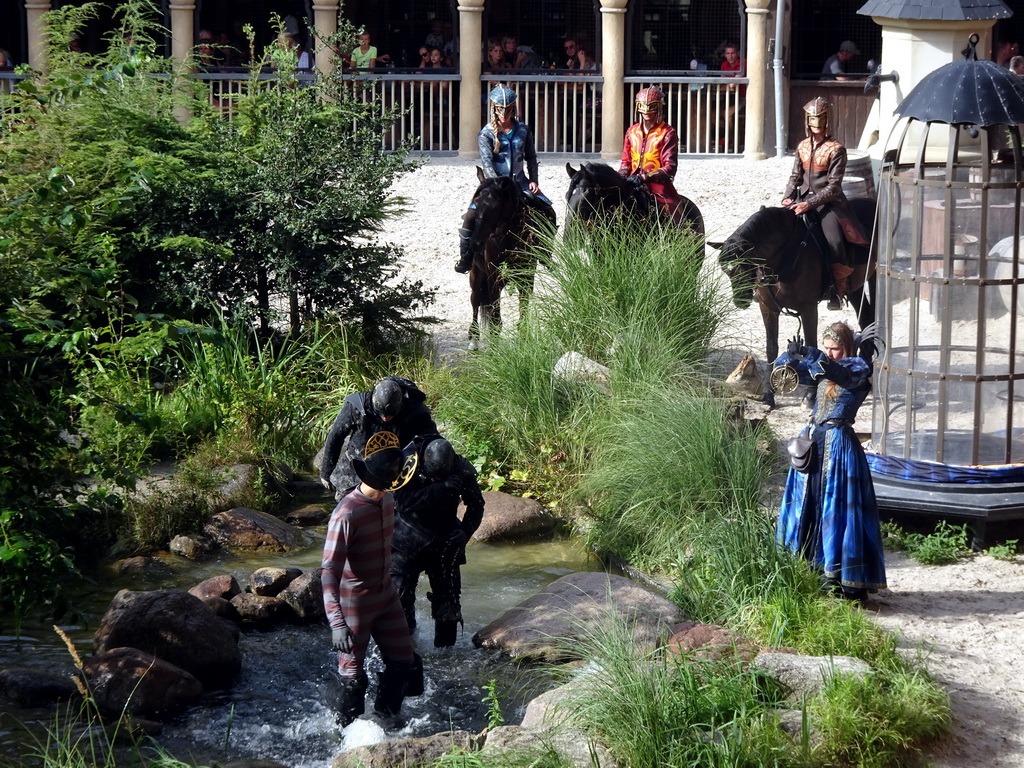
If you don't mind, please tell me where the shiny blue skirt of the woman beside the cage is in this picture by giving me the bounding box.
[776,426,886,592]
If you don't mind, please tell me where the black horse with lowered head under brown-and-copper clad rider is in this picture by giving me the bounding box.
[708,198,876,404]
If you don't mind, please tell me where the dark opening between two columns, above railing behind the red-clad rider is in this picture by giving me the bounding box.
[626,0,745,73]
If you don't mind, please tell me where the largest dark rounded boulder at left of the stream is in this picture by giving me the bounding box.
[93,590,242,688]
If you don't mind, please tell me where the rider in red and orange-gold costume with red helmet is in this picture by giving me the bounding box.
[618,86,683,224]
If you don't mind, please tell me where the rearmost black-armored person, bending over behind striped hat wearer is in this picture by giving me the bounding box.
[319,376,437,501]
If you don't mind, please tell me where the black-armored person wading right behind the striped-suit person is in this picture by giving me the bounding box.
[391,437,483,648]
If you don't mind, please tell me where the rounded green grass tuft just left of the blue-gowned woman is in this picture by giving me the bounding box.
[578,380,770,568]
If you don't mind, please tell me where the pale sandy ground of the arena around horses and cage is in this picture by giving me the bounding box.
[387,158,1024,768]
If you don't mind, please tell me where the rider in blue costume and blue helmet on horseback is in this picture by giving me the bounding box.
[455,85,557,273]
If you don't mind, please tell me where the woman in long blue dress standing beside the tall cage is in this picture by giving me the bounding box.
[775,323,886,600]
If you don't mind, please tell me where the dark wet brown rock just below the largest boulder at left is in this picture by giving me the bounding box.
[84,648,203,718]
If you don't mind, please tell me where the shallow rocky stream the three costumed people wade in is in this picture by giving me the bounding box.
[0,527,602,768]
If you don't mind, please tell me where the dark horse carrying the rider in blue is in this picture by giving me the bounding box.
[469,168,546,349]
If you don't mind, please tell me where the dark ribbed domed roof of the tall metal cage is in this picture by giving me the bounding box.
[895,35,1024,126]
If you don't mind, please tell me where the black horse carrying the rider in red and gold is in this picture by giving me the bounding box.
[565,163,705,238]
